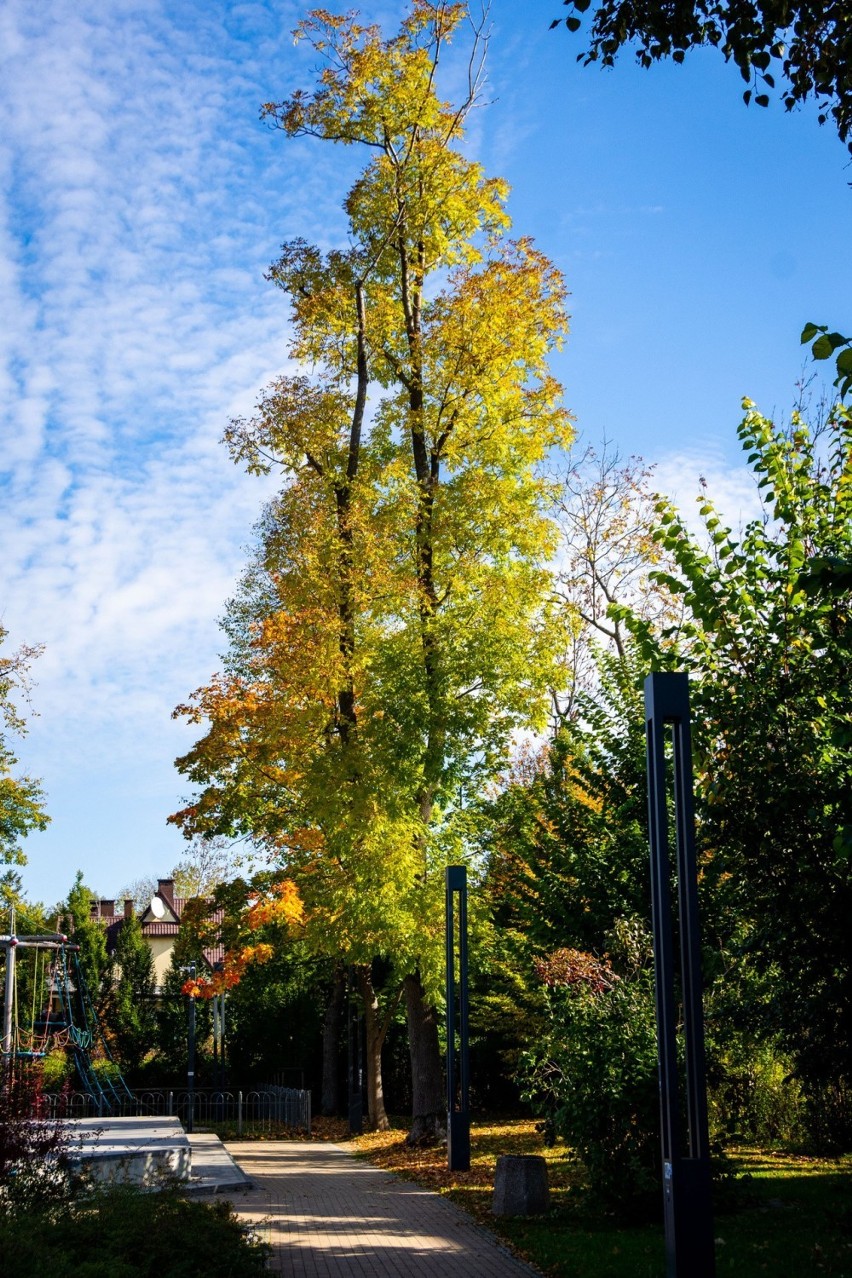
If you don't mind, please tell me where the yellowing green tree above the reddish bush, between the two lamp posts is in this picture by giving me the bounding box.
[488,652,650,955]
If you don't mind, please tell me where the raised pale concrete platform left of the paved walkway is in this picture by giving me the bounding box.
[66,1118,192,1186]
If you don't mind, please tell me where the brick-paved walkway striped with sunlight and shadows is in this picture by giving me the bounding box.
[227,1141,544,1278]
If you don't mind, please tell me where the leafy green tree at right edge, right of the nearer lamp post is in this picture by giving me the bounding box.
[625,405,852,1143]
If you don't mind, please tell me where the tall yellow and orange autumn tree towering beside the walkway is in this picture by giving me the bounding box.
[175,0,570,1135]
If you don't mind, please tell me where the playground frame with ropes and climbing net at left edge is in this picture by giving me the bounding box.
[0,910,133,1114]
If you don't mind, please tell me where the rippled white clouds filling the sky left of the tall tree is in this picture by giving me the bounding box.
[0,0,323,900]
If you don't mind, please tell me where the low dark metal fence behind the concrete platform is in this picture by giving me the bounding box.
[42,1084,310,1136]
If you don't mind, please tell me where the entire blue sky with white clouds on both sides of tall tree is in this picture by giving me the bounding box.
[0,0,852,902]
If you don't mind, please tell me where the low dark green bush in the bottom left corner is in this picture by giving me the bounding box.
[0,1186,268,1278]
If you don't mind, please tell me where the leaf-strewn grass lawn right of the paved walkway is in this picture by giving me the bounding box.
[347,1120,852,1278]
